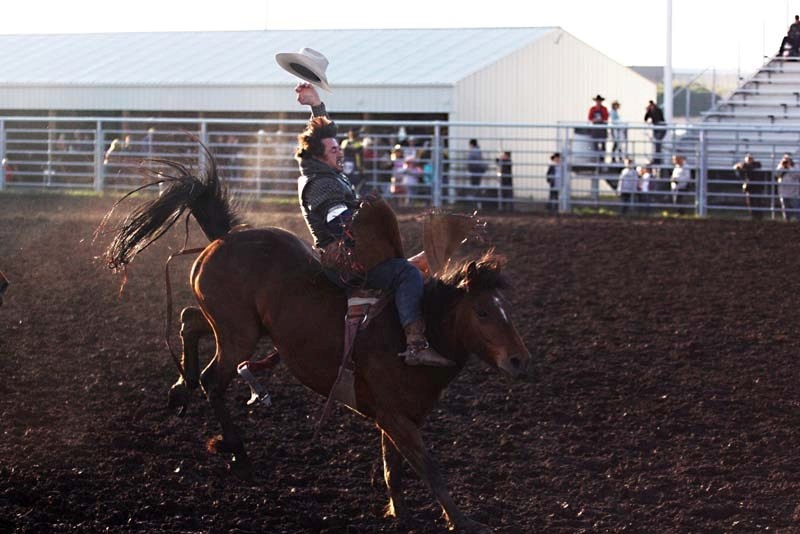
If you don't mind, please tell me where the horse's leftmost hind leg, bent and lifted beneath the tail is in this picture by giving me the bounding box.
[169,306,213,415]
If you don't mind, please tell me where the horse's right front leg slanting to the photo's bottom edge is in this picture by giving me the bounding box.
[378,414,492,533]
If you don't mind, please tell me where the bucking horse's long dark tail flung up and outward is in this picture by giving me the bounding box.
[98,143,241,270]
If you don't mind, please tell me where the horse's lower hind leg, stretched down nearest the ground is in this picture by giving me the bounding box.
[200,326,259,480]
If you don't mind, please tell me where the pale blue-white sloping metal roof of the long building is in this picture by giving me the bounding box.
[0,28,557,90]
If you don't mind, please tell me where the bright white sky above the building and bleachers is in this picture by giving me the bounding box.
[0,0,800,76]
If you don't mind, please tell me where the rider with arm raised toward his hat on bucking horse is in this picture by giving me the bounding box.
[295,82,454,367]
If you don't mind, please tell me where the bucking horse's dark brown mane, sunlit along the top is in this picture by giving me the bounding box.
[423,250,510,335]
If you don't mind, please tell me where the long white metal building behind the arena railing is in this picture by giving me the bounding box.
[0,28,656,123]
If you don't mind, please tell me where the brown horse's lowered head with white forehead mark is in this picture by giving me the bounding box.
[443,253,531,378]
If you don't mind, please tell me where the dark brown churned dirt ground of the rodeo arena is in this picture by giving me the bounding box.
[0,193,800,533]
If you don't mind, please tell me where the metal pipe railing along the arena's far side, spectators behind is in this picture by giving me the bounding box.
[0,117,800,220]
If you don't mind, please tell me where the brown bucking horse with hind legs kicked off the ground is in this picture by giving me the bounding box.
[107,149,530,532]
